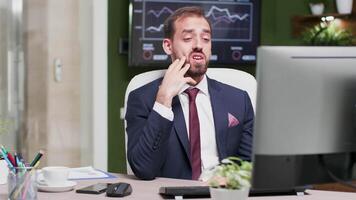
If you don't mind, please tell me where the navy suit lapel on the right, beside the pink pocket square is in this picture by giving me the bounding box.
[208,78,228,160]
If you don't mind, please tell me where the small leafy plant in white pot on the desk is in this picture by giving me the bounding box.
[201,157,252,200]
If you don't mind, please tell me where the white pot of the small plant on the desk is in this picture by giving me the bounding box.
[210,188,250,200]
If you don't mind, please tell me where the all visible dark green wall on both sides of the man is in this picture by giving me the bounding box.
[108,0,334,173]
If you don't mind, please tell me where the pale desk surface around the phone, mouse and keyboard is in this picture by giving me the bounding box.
[0,174,356,200]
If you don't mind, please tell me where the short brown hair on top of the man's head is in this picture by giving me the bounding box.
[164,6,211,39]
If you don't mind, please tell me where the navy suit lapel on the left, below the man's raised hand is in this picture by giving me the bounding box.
[172,96,190,160]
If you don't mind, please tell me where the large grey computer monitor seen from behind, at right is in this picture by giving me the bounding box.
[252,46,356,191]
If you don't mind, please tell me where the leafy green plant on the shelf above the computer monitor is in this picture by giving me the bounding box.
[302,22,354,46]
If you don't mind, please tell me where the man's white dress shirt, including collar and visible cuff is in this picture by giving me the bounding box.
[153,75,219,170]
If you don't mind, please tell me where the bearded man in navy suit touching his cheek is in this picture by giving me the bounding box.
[126,7,254,180]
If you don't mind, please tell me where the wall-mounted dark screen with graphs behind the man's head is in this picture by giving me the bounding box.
[129,0,260,67]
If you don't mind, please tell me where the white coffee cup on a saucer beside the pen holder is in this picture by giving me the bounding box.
[41,166,69,186]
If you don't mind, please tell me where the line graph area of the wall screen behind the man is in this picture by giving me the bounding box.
[142,1,253,41]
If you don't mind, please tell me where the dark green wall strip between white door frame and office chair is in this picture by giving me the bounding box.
[108,0,158,173]
